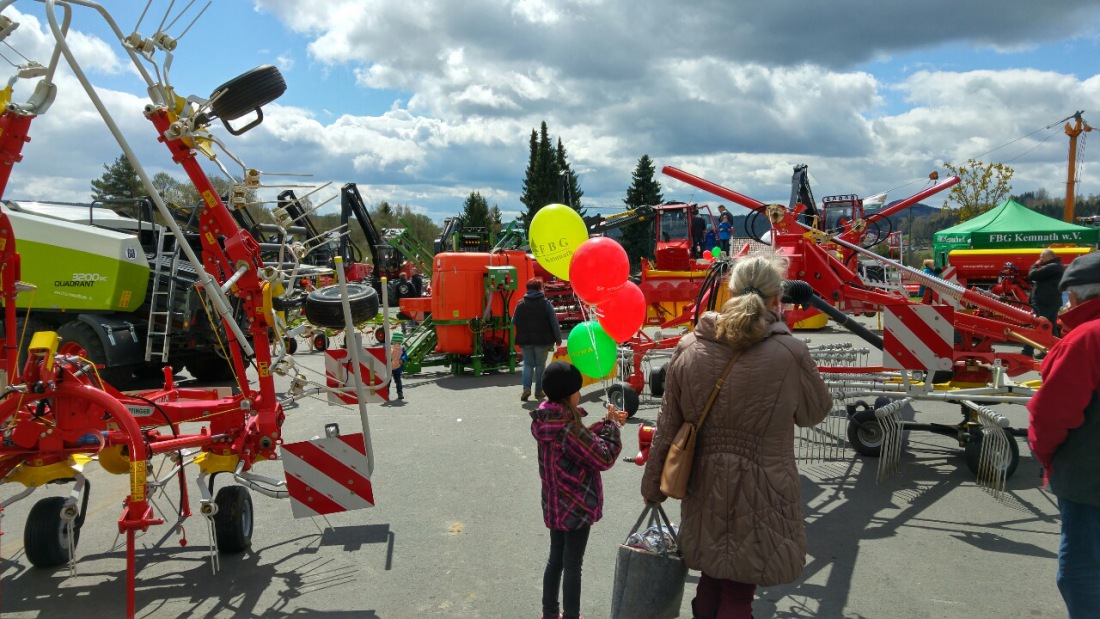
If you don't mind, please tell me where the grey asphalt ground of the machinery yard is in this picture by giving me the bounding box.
[0,319,1065,619]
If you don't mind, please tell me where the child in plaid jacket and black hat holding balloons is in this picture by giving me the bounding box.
[531,361,626,619]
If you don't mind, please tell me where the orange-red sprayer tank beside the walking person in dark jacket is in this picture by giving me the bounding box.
[431,250,535,355]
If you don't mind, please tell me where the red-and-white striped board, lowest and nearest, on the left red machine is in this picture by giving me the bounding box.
[282,434,374,518]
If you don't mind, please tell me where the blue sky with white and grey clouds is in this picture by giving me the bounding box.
[0,0,1100,221]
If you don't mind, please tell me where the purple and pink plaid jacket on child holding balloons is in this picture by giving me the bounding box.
[531,402,623,531]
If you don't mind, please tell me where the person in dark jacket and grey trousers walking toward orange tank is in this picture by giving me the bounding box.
[512,277,561,402]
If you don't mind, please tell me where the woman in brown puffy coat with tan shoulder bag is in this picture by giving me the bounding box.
[641,256,833,619]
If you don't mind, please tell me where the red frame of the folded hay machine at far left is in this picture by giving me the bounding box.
[0,0,365,617]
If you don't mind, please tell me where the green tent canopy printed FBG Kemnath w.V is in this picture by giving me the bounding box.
[932,200,1100,266]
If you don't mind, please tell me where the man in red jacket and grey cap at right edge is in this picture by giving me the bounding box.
[1027,252,1100,619]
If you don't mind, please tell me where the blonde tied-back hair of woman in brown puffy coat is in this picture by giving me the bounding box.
[717,254,788,350]
